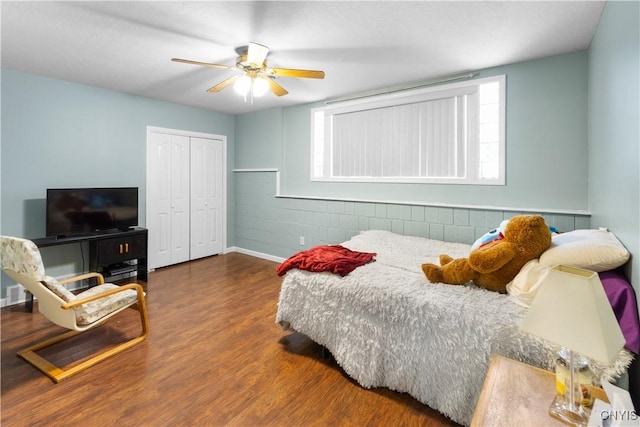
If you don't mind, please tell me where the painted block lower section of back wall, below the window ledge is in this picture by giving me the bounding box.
[234,172,590,261]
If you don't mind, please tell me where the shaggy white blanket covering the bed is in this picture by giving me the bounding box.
[276,230,637,425]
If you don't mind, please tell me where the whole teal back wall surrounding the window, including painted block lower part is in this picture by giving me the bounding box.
[234,51,590,258]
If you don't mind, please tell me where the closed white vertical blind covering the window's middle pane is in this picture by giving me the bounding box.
[332,95,467,178]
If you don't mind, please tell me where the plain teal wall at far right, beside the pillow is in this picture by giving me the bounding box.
[589,1,640,402]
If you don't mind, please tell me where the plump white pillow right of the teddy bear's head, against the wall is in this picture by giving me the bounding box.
[540,230,630,272]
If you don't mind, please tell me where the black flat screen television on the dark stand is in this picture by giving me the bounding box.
[46,187,138,237]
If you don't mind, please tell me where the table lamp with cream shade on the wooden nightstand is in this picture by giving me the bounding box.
[520,265,625,426]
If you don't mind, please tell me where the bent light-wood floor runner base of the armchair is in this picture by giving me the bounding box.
[18,300,149,383]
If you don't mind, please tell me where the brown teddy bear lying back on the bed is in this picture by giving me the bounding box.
[422,215,551,293]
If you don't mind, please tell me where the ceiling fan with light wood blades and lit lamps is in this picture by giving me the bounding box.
[171,42,324,100]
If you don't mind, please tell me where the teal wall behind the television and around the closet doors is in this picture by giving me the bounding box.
[1,69,235,288]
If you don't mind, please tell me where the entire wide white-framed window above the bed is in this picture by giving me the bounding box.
[311,76,505,185]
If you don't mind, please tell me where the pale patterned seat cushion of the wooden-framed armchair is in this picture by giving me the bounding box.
[74,283,138,325]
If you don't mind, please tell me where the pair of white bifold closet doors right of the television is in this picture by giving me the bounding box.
[147,132,224,269]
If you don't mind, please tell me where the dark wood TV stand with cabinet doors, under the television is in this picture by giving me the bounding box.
[27,227,148,309]
